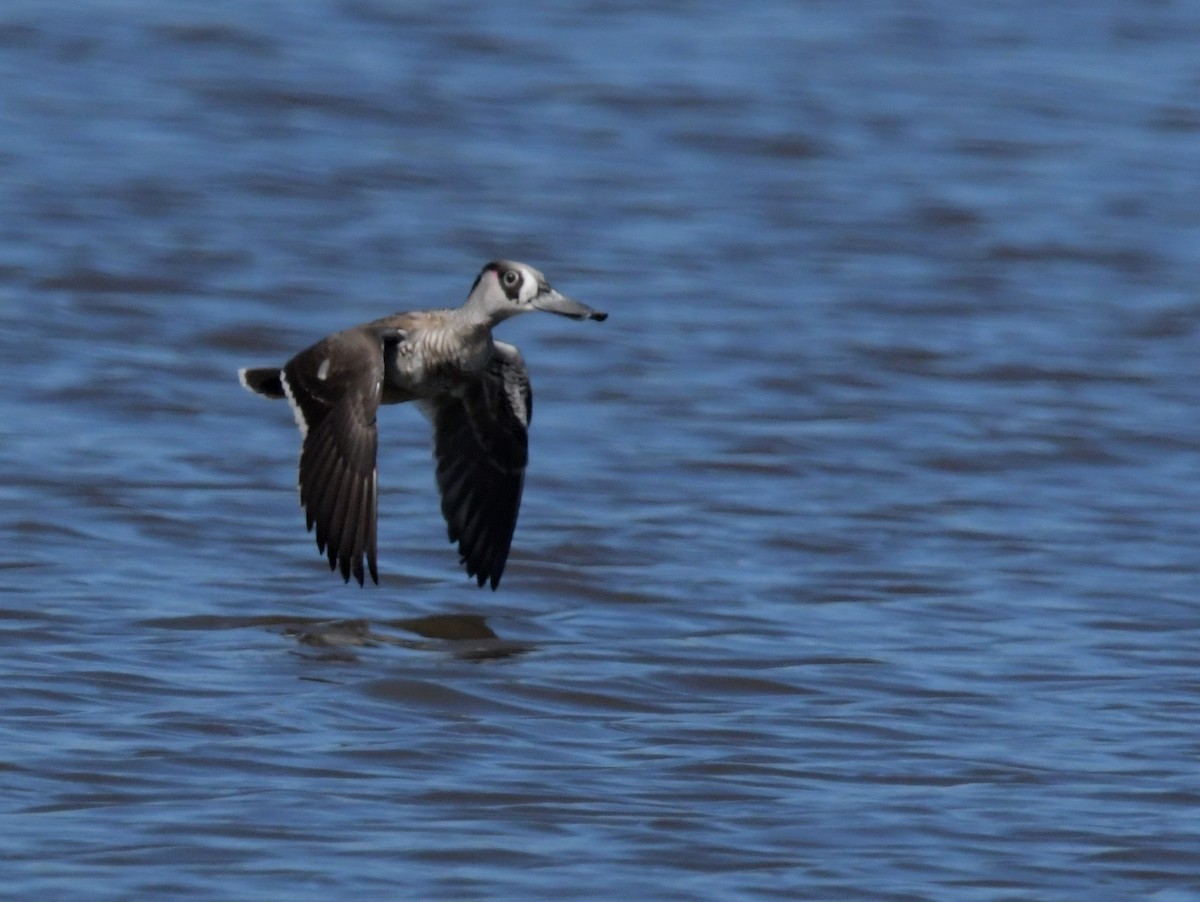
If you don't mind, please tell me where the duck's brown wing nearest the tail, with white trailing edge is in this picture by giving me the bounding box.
[280,327,384,585]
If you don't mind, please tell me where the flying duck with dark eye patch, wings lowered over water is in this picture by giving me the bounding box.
[238,260,608,590]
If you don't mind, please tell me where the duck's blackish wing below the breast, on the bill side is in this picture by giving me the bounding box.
[422,342,533,589]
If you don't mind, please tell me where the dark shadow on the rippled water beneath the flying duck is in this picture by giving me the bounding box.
[143,614,534,662]
